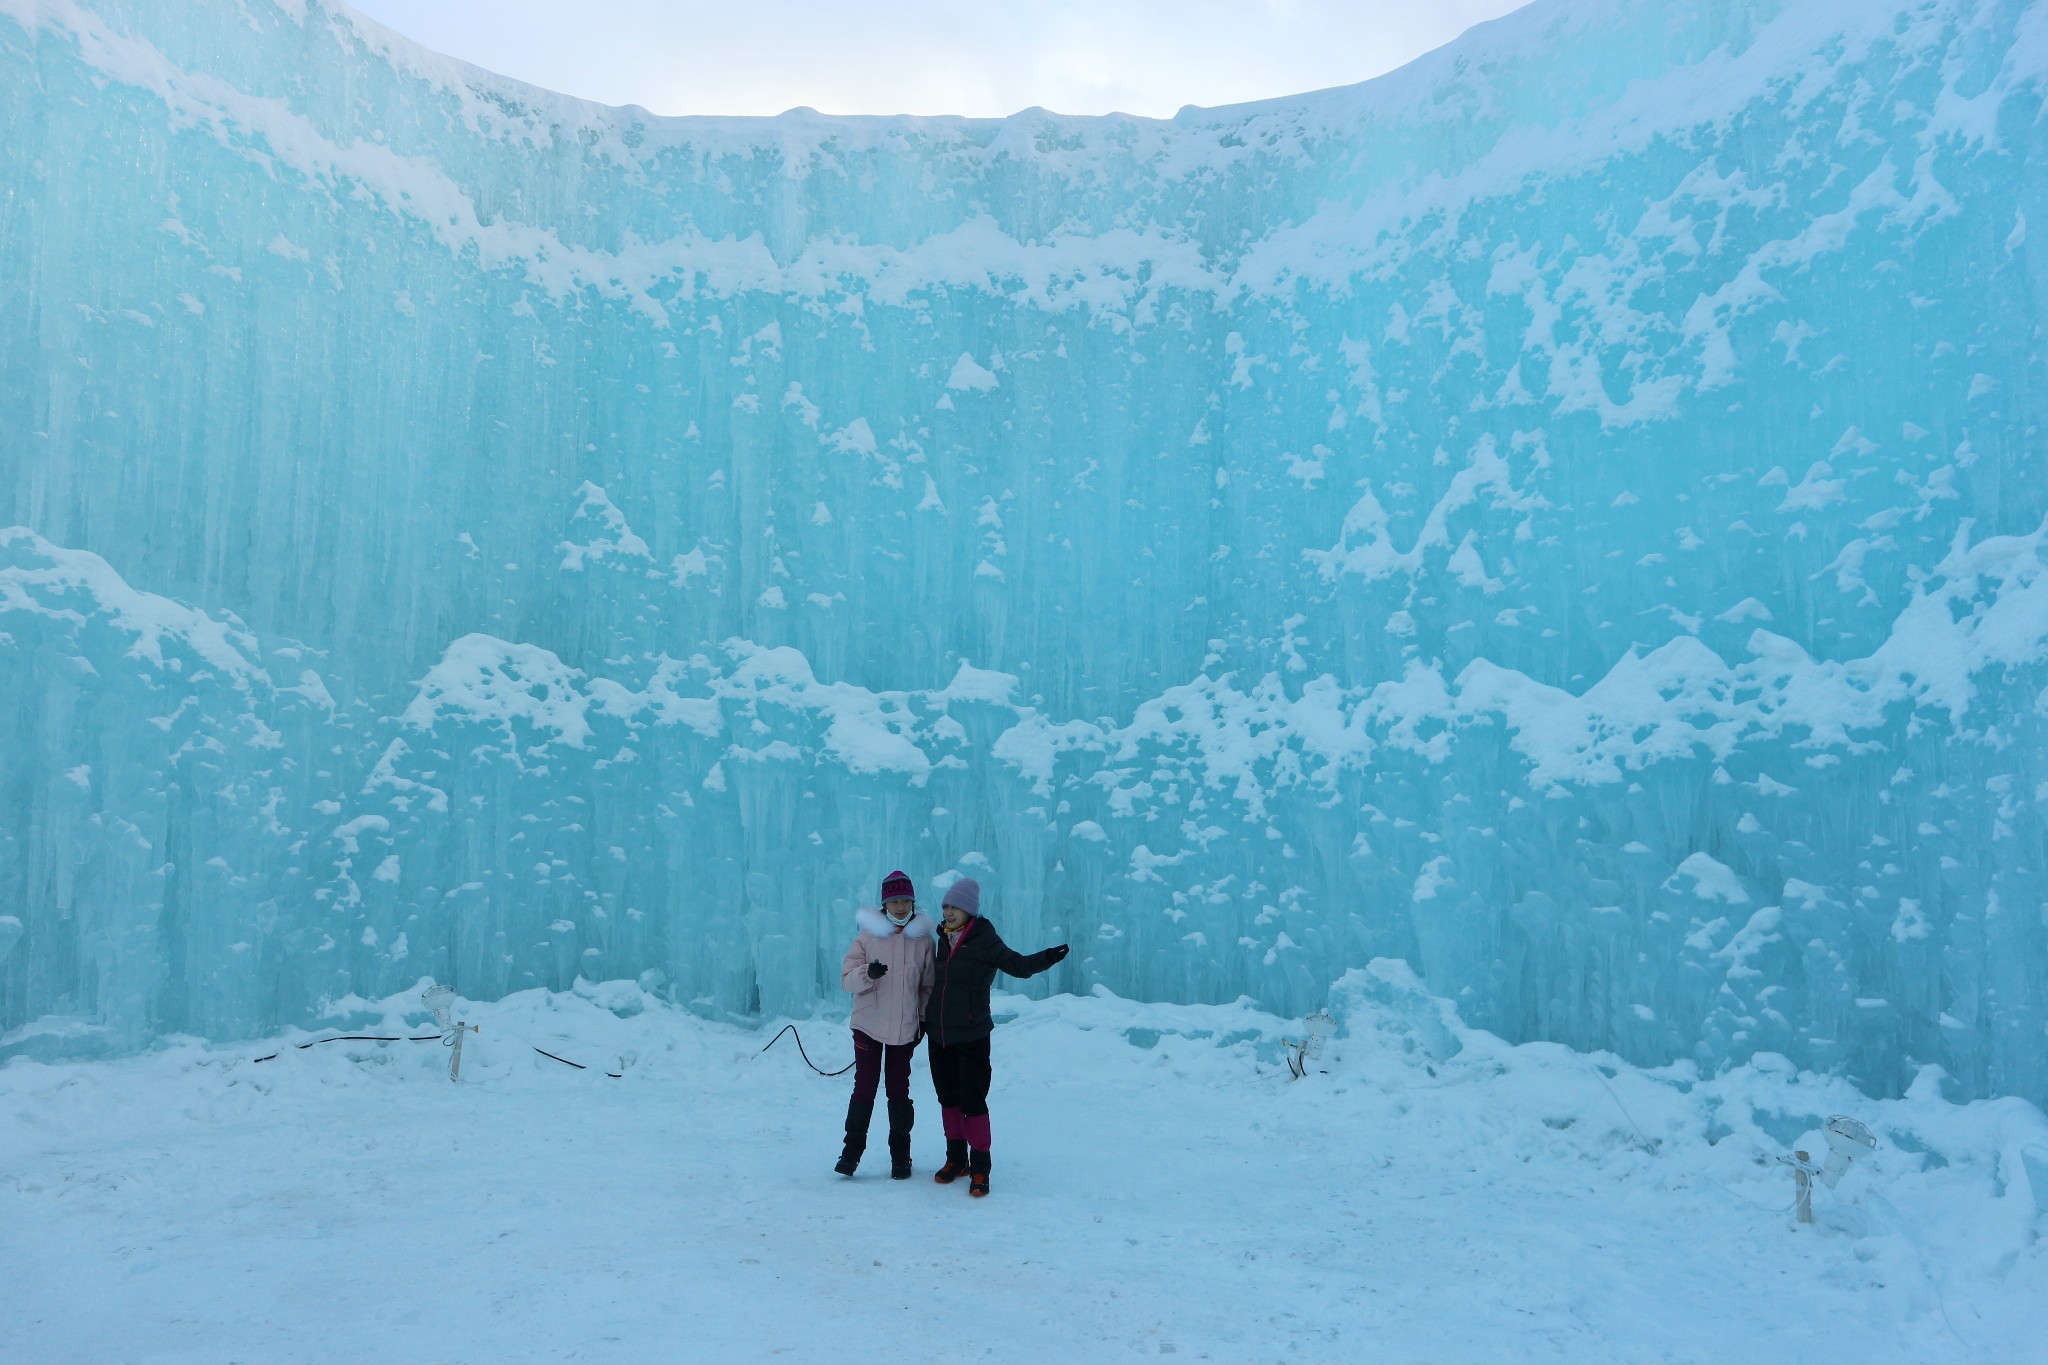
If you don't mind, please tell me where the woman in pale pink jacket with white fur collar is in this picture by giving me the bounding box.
[831,872,932,1181]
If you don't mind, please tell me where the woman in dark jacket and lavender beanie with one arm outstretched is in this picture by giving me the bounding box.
[924,878,1067,1199]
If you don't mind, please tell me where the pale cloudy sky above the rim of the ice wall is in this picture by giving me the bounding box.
[350,0,1524,119]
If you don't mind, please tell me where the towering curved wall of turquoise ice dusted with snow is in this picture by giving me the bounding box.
[0,0,2048,1099]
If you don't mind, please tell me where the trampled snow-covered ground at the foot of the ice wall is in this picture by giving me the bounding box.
[0,964,2048,1365]
